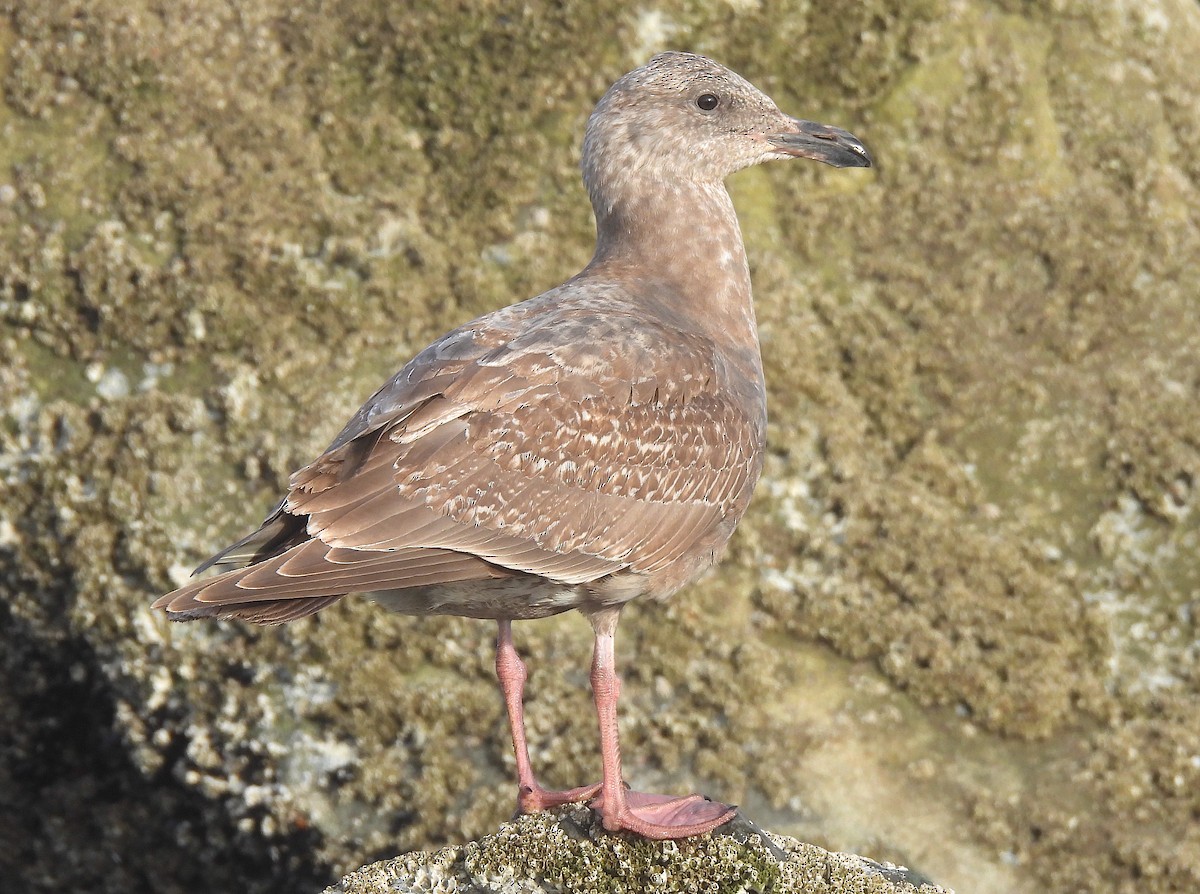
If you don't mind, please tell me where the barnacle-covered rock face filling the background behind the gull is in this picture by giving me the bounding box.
[0,0,1200,894]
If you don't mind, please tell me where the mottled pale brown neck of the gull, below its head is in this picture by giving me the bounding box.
[588,179,762,378]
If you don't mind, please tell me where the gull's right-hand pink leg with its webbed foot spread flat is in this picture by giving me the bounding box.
[589,608,737,840]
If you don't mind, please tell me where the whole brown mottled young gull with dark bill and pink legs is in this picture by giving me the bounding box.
[155,53,871,839]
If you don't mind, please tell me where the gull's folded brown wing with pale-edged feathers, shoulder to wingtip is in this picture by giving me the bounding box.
[156,292,762,623]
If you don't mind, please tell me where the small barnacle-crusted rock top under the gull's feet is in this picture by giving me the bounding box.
[324,806,953,894]
